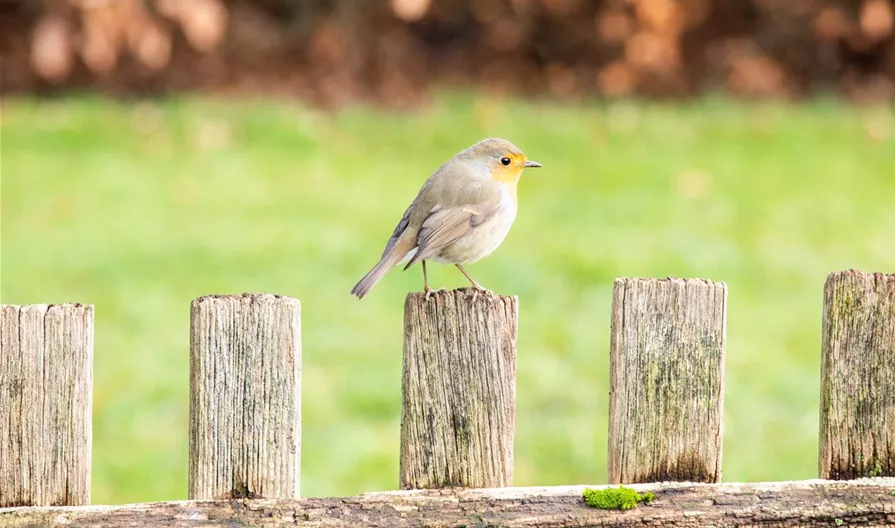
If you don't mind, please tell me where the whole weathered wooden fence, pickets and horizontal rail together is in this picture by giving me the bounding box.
[0,270,895,527]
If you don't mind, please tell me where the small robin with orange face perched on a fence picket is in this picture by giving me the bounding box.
[351,138,541,299]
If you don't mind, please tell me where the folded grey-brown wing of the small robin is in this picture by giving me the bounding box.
[404,193,501,269]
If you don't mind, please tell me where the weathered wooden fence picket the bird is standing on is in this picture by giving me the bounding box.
[400,289,518,489]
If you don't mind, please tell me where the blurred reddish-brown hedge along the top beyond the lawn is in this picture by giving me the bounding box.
[0,0,895,105]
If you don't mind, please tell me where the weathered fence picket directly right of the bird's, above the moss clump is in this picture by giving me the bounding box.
[608,278,727,483]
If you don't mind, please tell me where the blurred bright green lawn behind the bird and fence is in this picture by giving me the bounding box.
[0,95,895,503]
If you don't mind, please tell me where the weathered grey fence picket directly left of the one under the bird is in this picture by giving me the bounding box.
[189,294,301,499]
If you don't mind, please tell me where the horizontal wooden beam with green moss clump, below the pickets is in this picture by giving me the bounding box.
[0,478,895,528]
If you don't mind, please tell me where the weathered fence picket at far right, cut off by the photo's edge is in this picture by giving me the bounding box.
[820,270,895,479]
